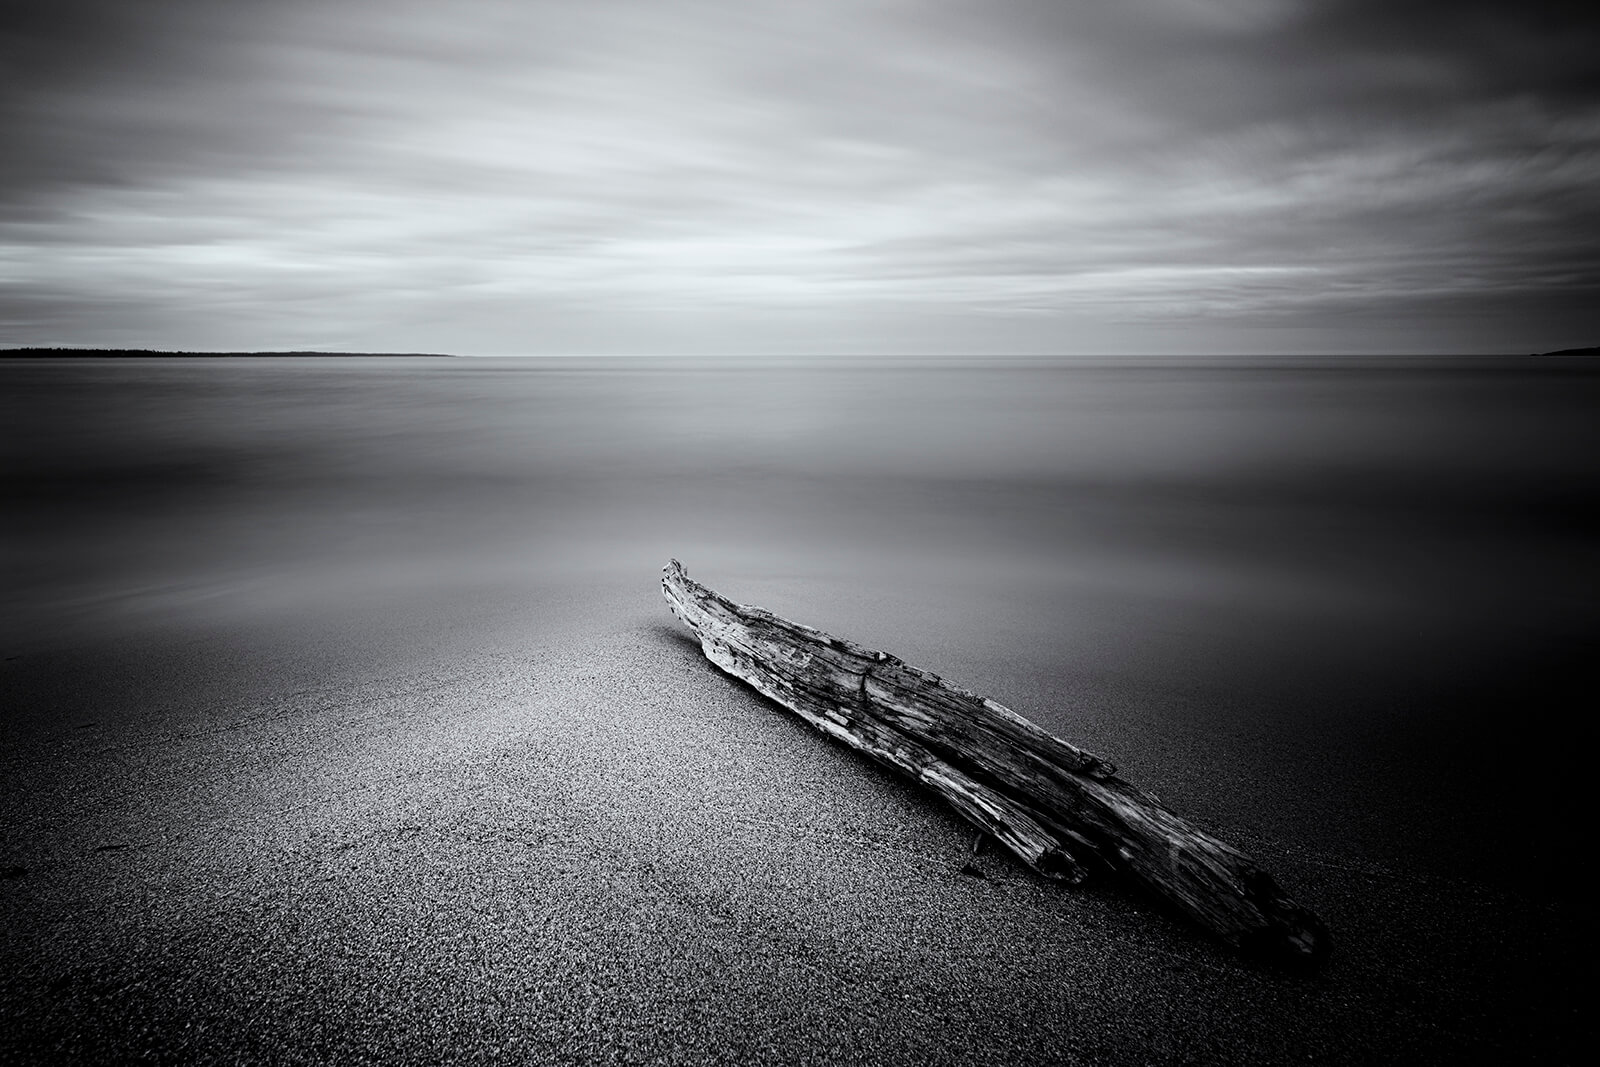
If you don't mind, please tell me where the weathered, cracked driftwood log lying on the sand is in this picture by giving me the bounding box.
[661,560,1328,963]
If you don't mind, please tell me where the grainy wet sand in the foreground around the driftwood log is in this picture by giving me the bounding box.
[0,573,1587,1064]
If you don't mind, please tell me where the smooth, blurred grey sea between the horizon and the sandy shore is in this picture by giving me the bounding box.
[0,360,1600,630]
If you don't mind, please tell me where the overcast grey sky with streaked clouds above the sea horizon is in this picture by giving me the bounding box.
[0,0,1600,355]
